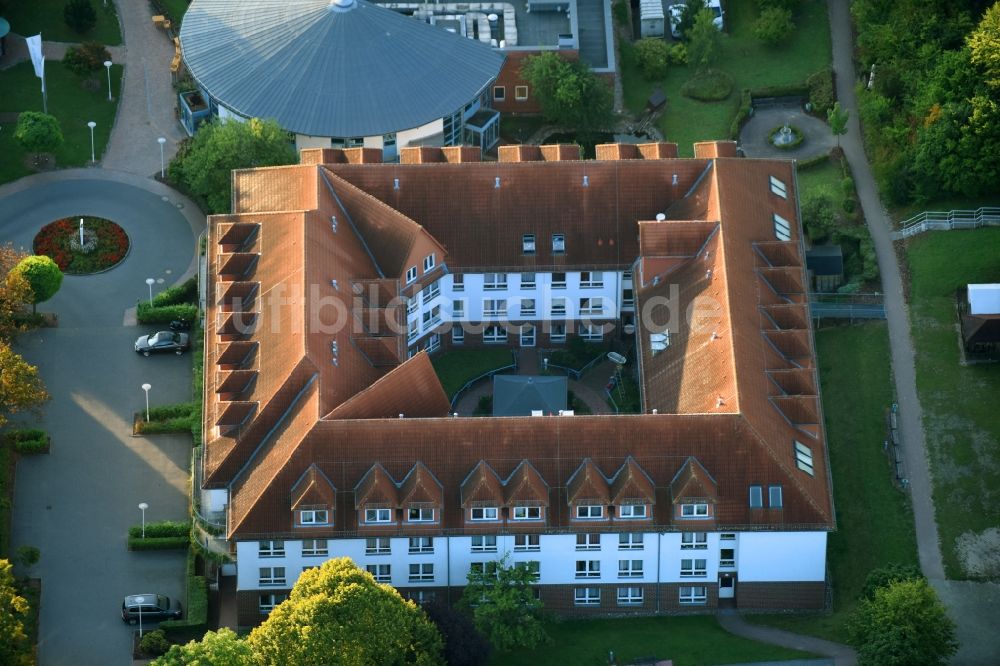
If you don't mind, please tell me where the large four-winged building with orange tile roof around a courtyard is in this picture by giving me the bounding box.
[198,142,835,625]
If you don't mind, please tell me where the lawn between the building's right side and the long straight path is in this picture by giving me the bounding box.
[748,321,917,643]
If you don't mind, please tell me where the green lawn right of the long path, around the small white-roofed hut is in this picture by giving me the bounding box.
[903,227,1000,578]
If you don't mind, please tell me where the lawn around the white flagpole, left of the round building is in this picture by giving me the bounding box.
[0,61,123,183]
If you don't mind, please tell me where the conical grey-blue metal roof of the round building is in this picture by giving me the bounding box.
[180,0,504,137]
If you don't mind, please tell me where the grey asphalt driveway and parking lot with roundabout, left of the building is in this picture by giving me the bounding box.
[0,171,204,666]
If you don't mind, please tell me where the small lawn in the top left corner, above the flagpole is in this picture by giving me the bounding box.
[4,0,122,45]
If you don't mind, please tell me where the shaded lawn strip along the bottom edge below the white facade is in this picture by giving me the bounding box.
[490,615,812,666]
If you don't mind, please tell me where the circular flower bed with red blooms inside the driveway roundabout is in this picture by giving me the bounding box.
[33,215,130,275]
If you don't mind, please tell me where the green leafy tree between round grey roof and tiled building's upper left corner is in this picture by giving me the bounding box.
[170,118,296,213]
